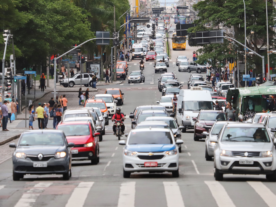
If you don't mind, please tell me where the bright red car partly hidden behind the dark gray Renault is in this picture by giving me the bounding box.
[57,121,100,165]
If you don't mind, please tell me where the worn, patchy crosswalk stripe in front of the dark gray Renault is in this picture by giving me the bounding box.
[15,182,52,207]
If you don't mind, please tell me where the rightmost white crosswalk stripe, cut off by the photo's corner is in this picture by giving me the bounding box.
[247,182,276,207]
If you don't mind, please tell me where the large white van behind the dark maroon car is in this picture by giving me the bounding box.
[176,87,214,132]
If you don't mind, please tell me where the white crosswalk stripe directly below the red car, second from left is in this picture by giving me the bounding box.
[66,182,94,207]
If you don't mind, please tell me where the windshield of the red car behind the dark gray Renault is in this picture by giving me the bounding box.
[58,124,90,136]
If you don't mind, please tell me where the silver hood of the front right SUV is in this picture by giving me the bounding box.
[220,142,272,151]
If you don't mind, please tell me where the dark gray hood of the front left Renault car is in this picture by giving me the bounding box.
[16,146,65,155]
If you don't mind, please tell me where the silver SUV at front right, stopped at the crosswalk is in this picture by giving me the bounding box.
[214,123,276,181]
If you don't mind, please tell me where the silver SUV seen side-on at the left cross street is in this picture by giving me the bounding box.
[60,73,92,87]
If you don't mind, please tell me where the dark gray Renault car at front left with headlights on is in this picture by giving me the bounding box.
[10,130,74,180]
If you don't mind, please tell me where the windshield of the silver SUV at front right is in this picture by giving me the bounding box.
[221,127,270,142]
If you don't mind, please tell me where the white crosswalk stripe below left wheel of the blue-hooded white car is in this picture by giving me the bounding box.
[118,182,135,207]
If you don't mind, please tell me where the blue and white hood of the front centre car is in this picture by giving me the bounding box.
[127,144,175,152]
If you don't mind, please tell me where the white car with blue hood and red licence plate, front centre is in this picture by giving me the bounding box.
[119,128,183,178]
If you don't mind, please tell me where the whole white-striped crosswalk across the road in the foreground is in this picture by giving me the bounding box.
[0,179,276,207]
